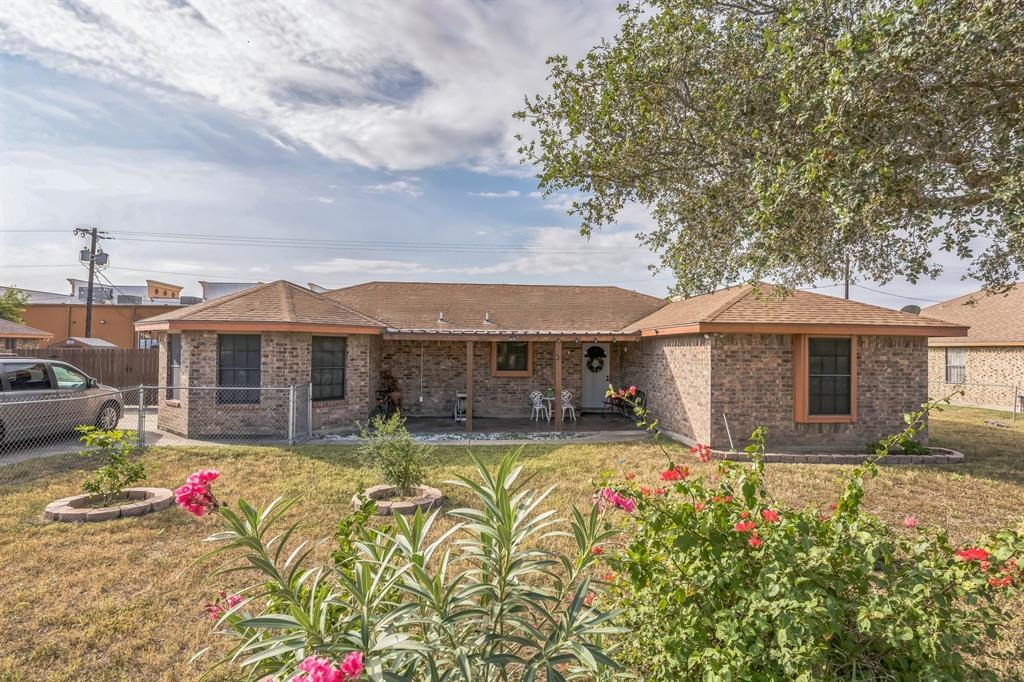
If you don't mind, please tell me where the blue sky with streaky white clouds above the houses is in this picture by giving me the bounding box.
[0,0,976,307]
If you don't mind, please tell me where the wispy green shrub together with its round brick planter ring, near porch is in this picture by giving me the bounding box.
[352,412,444,516]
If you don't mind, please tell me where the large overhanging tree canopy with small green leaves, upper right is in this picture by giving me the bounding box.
[516,0,1024,294]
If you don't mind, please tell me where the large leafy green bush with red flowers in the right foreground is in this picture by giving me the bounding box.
[601,391,1024,680]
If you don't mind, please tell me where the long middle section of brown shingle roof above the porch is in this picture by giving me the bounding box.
[324,282,665,333]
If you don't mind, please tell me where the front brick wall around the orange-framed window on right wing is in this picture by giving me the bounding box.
[710,334,928,451]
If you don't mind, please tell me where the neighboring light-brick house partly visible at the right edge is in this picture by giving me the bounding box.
[922,282,1024,411]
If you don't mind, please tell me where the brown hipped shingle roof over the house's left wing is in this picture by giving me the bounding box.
[139,280,383,328]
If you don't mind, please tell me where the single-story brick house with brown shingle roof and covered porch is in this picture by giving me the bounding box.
[136,282,967,450]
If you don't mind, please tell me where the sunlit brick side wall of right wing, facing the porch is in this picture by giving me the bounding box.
[618,335,711,442]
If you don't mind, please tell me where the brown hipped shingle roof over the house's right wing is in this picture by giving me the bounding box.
[629,285,966,333]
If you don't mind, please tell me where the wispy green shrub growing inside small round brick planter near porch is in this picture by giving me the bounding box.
[359,412,432,496]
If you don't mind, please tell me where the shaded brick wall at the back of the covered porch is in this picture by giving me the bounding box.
[381,339,583,417]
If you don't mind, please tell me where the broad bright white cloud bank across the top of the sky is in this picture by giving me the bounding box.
[0,0,618,173]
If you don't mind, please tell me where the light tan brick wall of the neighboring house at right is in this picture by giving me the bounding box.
[928,346,1024,411]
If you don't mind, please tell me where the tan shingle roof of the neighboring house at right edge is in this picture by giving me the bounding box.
[922,282,1024,346]
